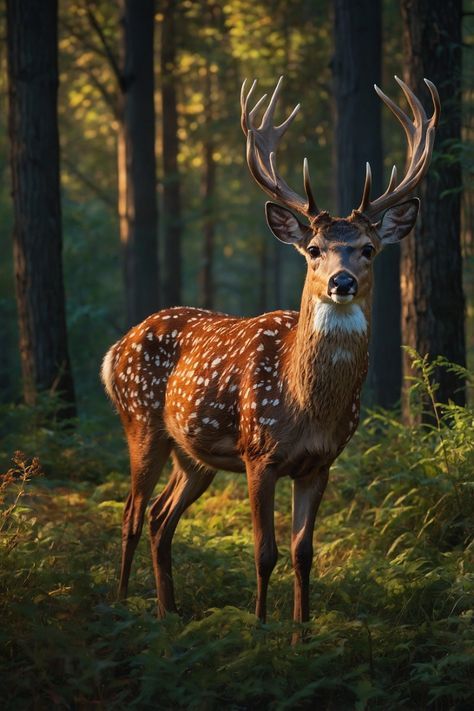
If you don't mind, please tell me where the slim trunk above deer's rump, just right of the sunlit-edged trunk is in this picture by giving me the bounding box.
[161,0,181,306]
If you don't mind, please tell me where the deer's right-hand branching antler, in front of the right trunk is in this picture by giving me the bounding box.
[357,76,441,219]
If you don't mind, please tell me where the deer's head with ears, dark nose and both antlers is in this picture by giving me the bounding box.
[241,77,440,304]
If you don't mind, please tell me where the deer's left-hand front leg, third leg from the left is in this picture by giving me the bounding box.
[247,464,278,622]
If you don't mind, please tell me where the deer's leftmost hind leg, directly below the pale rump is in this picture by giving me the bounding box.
[118,434,171,599]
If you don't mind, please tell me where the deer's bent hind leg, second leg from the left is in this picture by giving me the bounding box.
[150,452,216,617]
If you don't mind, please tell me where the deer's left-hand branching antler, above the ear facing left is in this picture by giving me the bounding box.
[240,77,319,219]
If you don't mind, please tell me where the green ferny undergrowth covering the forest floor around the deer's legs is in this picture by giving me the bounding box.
[0,357,474,711]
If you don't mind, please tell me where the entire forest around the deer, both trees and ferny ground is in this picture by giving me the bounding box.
[0,0,474,711]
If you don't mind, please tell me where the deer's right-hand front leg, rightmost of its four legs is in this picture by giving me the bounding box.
[291,467,329,622]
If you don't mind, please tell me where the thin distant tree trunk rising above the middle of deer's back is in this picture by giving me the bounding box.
[201,65,216,309]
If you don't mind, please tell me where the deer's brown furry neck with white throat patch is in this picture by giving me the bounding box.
[287,278,370,419]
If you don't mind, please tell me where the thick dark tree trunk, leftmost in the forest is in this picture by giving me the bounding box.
[7,0,75,417]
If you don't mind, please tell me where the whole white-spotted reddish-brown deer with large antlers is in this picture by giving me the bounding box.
[101,72,440,623]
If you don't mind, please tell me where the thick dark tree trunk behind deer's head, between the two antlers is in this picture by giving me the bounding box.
[333,0,401,407]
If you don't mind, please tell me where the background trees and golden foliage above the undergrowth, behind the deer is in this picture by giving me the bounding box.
[0,0,472,416]
